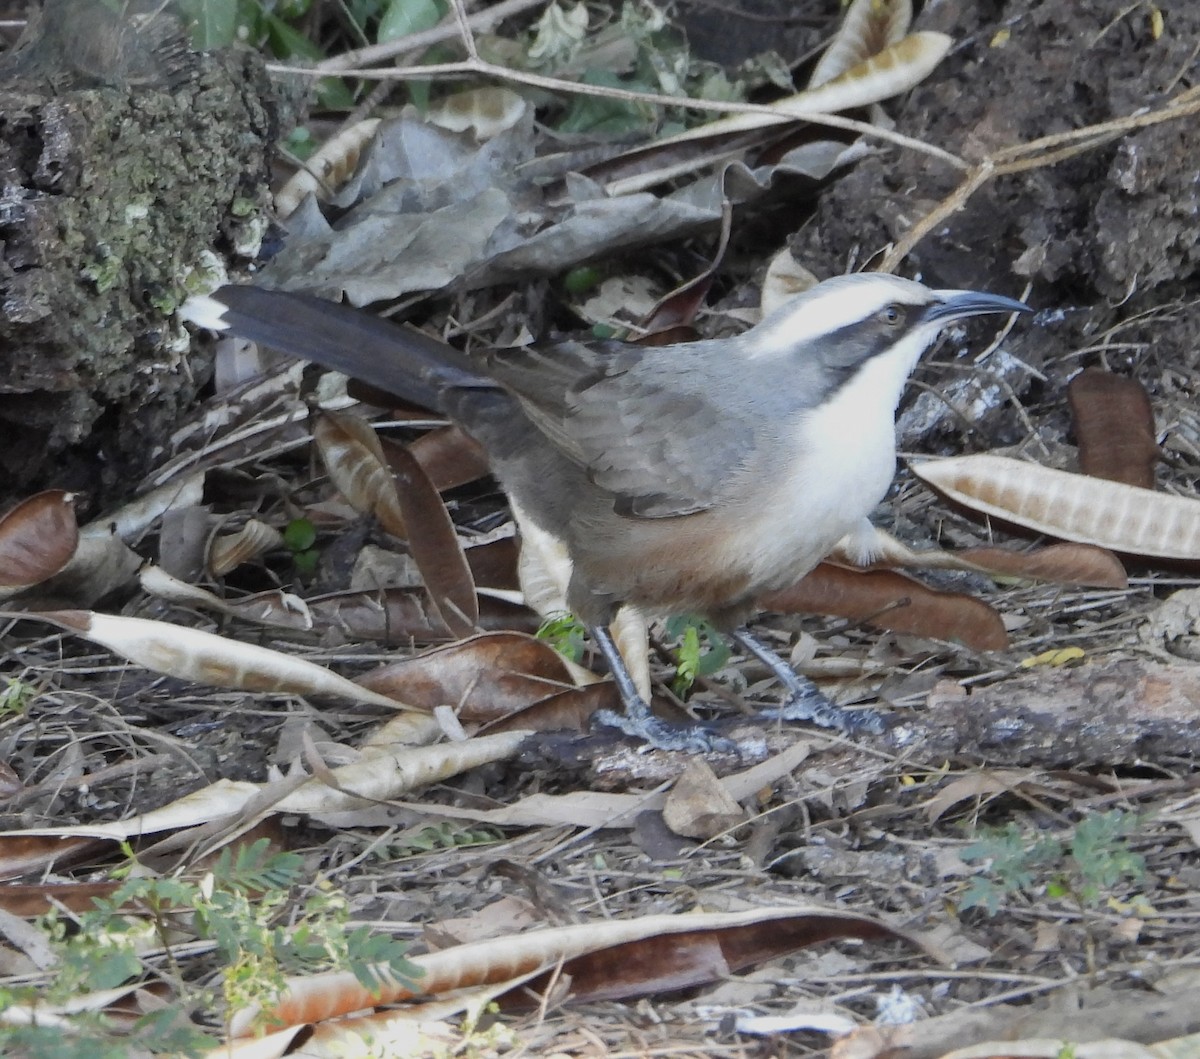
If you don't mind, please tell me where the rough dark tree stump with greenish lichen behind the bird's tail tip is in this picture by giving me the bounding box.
[0,0,276,499]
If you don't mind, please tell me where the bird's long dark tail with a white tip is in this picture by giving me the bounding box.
[204,286,496,412]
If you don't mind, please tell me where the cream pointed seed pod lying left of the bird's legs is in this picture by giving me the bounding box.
[29,610,415,710]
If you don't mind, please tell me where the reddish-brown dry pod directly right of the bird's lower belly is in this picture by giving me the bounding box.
[760,563,1008,651]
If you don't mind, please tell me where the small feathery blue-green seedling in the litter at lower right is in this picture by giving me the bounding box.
[961,809,1146,914]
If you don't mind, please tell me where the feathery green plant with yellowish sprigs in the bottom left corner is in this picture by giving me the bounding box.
[0,839,420,1059]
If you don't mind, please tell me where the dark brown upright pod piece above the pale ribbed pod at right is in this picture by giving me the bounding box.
[1067,367,1160,489]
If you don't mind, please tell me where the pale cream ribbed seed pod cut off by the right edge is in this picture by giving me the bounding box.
[912,455,1200,560]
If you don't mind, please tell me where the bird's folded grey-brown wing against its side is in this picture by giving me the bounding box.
[488,342,755,519]
